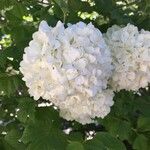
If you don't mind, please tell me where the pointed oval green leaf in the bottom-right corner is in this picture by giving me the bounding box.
[133,134,150,150]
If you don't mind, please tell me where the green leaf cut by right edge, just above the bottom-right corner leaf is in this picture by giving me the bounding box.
[137,117,150,132]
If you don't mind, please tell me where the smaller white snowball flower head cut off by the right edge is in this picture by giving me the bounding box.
[104,24,150,91]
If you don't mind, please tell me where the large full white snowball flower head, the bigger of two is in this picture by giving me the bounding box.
[20,21,113,124]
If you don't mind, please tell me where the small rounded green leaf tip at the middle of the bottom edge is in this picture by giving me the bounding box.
[66,142,84,150]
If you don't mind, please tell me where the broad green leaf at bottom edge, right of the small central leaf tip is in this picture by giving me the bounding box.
[85,132,126,150]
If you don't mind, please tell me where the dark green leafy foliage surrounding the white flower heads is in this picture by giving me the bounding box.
[0,0,150,150]
